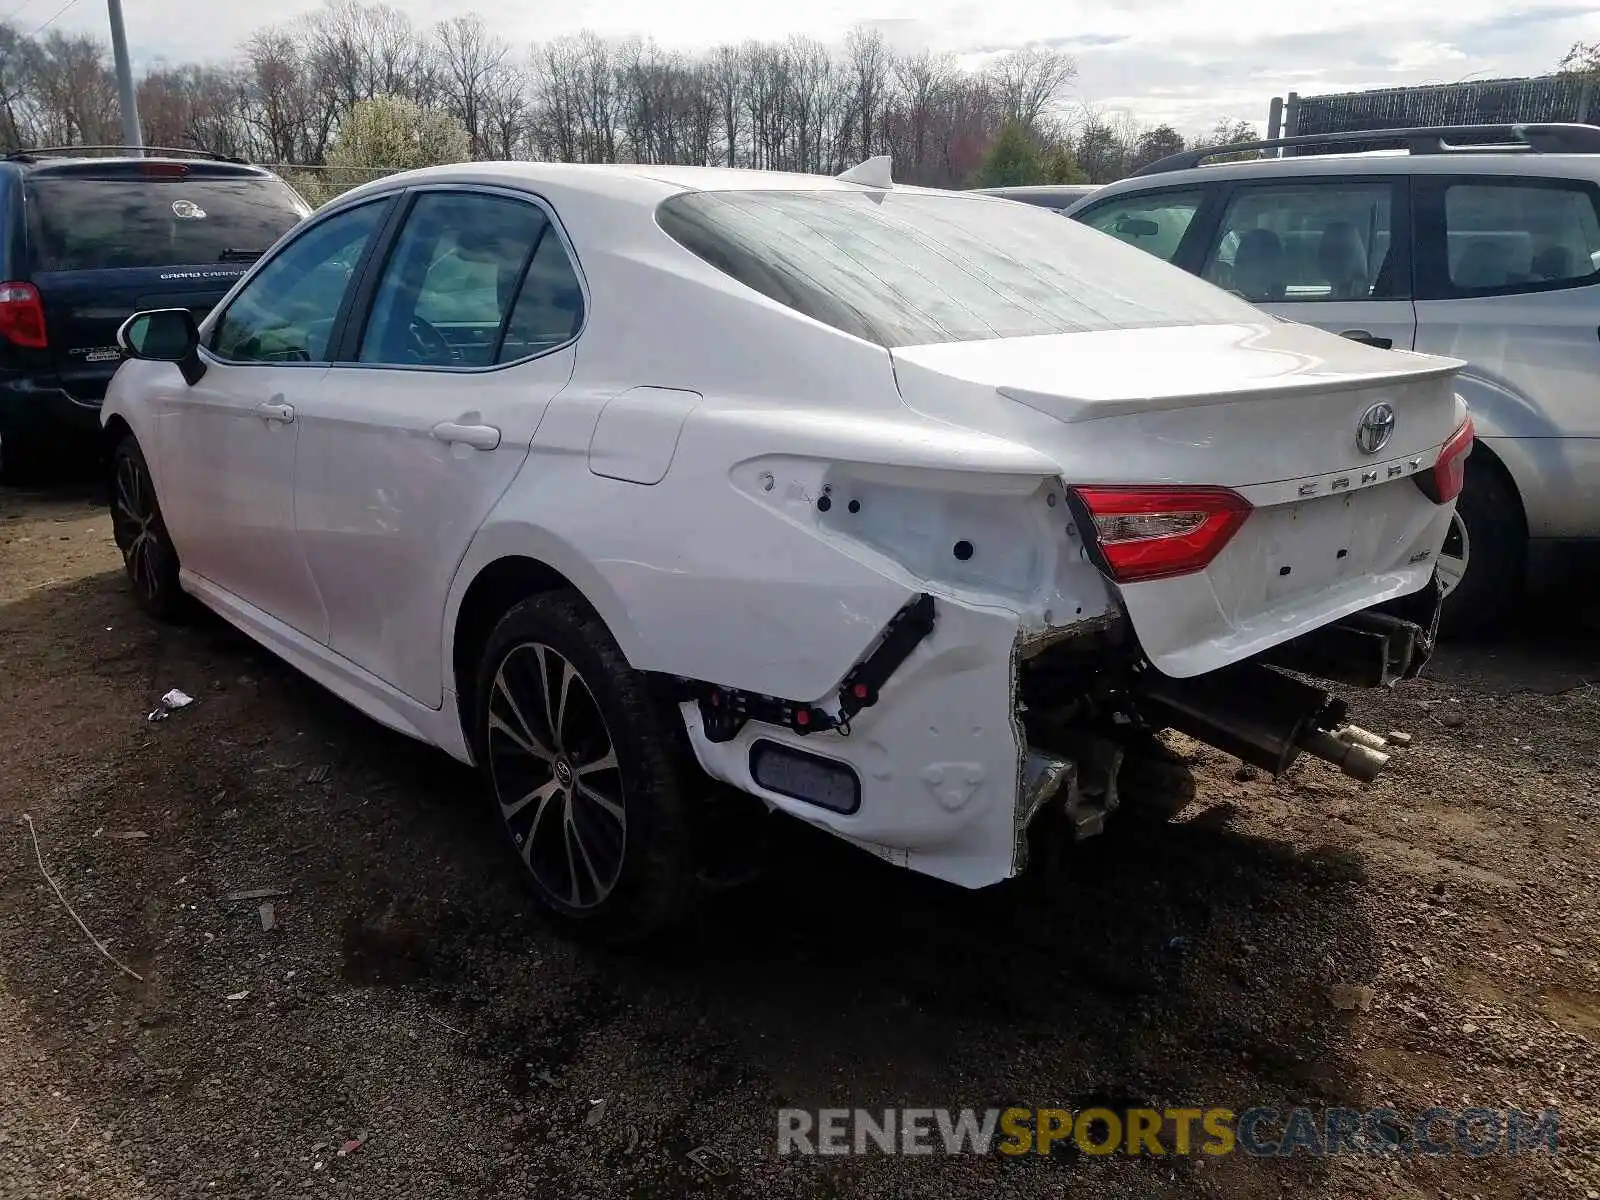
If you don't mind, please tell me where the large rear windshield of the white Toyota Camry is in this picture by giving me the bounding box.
[658,190,1261,347]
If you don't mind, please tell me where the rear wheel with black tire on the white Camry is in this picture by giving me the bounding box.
[474,592,694,942]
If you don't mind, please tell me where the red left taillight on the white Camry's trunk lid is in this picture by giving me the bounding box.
[1072,486,1250,584]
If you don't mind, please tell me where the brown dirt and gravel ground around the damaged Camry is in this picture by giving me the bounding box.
[0,490,1600,1200]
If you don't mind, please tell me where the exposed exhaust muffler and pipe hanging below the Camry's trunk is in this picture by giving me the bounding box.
[1134,662,1389,782]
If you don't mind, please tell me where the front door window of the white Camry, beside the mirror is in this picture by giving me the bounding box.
[211,200,387,363]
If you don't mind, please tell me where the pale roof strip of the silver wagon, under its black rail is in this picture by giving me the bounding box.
[1093,150,1600,202]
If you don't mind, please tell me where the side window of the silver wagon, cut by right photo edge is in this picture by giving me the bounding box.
[1445,179,1600,293]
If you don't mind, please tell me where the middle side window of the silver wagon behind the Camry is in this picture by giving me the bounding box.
[1203,181,1410,302]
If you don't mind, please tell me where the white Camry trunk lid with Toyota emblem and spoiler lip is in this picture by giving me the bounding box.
[893,318,1466,677]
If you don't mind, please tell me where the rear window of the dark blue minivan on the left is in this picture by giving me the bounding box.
[27,174,309,270]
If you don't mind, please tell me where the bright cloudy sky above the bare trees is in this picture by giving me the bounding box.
[31,0,1600,131]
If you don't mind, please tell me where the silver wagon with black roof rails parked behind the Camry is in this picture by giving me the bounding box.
[1067,125,1600,634]
